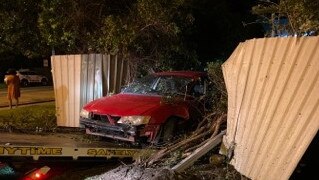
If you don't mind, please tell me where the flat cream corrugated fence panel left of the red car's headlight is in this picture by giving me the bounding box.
[51,55,81,127]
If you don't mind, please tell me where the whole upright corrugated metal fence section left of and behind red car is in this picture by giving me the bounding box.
[51,54,128,127]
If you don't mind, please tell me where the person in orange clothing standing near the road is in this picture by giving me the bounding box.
[5,69,20,109]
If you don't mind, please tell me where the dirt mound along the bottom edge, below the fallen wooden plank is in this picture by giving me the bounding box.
[86,164,247,180]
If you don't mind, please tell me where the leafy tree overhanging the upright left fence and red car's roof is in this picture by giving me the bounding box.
[38,0,197,73]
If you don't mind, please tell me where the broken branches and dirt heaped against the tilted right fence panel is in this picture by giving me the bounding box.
[88,113,245,180]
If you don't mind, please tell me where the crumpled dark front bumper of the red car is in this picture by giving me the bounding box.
[80,117,139,142]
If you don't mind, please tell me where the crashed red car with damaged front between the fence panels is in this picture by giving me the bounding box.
[80,71,207,143]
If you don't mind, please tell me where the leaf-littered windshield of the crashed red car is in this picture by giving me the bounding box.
[122,75,192,95]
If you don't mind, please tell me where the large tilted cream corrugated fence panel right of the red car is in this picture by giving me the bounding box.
[223,37,319,179]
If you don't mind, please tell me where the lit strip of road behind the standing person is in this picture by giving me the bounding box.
[0,86,54,108]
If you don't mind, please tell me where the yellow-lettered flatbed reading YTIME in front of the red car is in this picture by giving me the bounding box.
[0,133,149,160]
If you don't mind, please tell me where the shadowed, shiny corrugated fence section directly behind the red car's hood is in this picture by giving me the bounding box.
[81,54,128,107]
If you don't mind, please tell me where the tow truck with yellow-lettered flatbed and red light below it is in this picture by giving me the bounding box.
[0,132,152,179]
